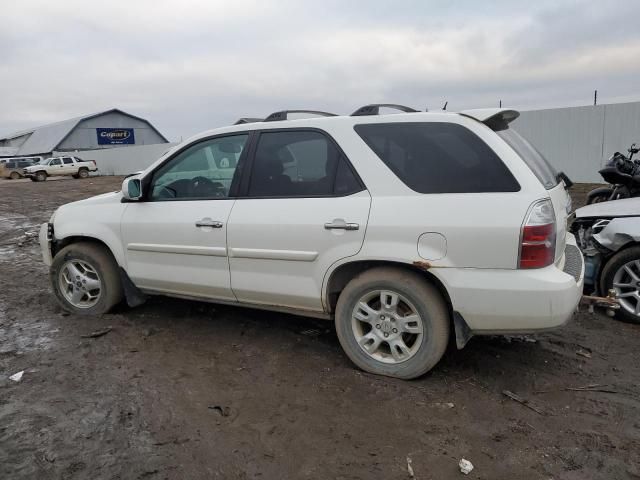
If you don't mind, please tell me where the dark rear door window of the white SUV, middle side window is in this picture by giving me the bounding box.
[248,130,363,197]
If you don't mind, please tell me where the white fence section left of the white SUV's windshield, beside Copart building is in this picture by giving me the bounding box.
[54,143,177,175]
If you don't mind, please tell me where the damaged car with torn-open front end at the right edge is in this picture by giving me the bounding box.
[571,198,640,323]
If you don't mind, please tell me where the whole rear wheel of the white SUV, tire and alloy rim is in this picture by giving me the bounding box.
[335,267,449,379]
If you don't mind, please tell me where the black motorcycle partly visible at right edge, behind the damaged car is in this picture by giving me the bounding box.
[587,143,640,205]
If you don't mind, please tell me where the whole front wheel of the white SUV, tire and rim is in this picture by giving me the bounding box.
[50,242,123,315]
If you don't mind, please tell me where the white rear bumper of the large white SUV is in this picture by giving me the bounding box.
[441,235,584,335]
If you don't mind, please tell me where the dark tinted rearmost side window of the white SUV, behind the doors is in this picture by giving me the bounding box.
[355,122,520,193]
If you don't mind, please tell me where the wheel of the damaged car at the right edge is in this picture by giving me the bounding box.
[600,246,640,323]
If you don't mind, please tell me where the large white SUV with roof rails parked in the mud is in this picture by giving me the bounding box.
[40,105,584,378]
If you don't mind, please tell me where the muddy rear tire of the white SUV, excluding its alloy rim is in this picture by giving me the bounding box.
[335,267,450,379]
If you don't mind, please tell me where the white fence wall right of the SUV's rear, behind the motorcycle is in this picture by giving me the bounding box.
[512,102,640,183]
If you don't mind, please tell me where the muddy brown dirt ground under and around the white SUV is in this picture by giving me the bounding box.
[0,177,640,480]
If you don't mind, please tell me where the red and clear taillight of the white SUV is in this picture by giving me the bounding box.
[519,200,556,268]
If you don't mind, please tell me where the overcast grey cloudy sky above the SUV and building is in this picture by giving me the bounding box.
[0,0,640,140]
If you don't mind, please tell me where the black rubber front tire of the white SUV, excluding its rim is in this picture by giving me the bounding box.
[49,242,123,315]
